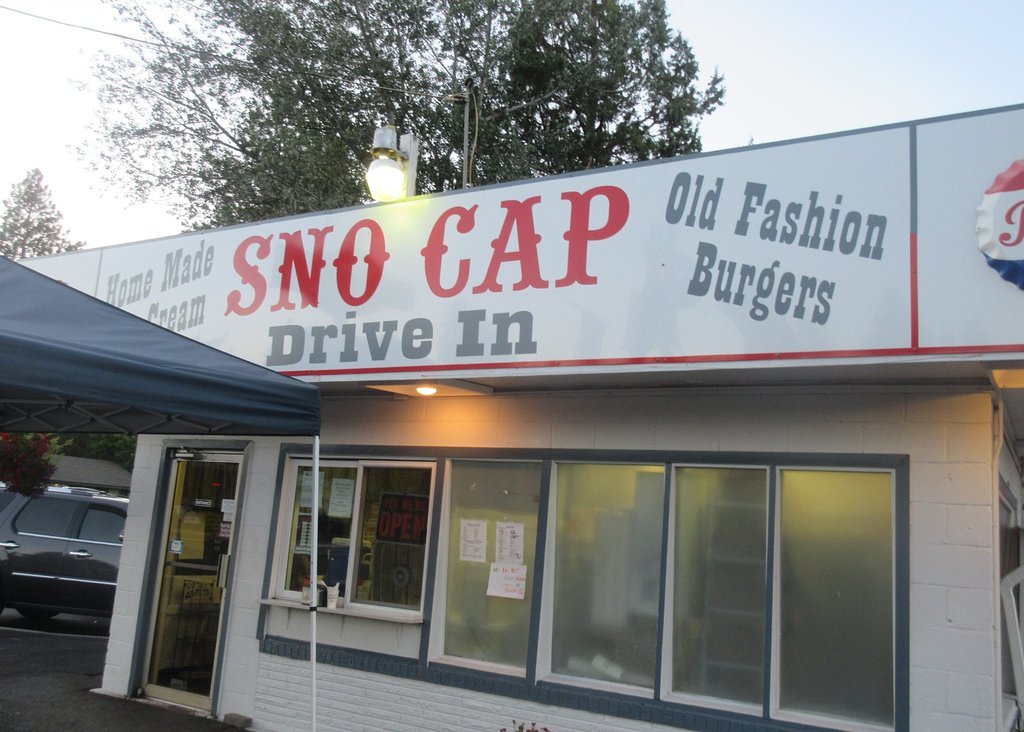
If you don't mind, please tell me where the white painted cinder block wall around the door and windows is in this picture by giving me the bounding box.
[97,389,999,732]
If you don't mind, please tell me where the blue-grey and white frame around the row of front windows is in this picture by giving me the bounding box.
[264,445,910,732]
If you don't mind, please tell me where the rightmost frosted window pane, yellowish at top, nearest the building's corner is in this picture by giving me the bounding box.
[774,470,893,725]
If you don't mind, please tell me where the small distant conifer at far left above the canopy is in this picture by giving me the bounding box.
[0,168,84,259]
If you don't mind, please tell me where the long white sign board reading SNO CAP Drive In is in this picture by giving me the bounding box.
[28,103,1024,380]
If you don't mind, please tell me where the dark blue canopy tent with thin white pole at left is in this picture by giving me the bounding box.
[0,257,321,729]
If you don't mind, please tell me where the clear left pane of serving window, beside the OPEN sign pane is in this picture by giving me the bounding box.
[285,464,362,593]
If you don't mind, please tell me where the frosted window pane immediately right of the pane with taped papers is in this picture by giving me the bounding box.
[551,464,665,688]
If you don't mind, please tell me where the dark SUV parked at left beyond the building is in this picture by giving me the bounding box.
[0,484,128,617]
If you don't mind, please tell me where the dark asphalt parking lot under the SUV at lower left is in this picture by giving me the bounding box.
[0,610,236,732]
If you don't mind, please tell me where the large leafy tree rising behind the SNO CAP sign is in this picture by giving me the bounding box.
[97,0,724,227]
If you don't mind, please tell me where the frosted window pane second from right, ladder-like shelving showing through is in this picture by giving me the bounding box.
[672,467,768,704]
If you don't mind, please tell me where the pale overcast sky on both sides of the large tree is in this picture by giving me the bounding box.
[0,0,1024,247]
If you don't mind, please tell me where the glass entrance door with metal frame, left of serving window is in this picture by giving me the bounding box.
[145,454,241,711]
